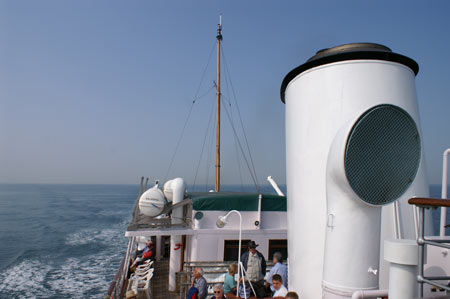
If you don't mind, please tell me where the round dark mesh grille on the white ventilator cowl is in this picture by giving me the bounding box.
[344,105,421,205]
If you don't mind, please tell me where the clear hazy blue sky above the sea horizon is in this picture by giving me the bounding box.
[0,0,450,184]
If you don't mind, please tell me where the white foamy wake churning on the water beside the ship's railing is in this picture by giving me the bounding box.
[0,229,126,298]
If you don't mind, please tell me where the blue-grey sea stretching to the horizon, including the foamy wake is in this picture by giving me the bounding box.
[0,184,450,298]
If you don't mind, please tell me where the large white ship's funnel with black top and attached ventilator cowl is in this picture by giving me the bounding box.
[281,43,431,299]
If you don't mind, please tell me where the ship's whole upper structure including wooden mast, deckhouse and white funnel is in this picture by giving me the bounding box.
[106,24,450,299]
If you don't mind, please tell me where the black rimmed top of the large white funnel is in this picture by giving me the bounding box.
[280,43,419,103]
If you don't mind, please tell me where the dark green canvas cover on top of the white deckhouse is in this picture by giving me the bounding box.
[187,192,286,212]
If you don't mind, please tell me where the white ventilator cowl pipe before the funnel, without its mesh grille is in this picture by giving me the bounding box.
[322,114,381,299]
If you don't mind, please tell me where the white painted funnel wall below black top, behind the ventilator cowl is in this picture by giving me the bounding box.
[285,60,431,299]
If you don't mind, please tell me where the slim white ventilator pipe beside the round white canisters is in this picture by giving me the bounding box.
[164,178,186,292]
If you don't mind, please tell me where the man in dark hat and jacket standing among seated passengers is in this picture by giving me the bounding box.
[241,241,266,297]
